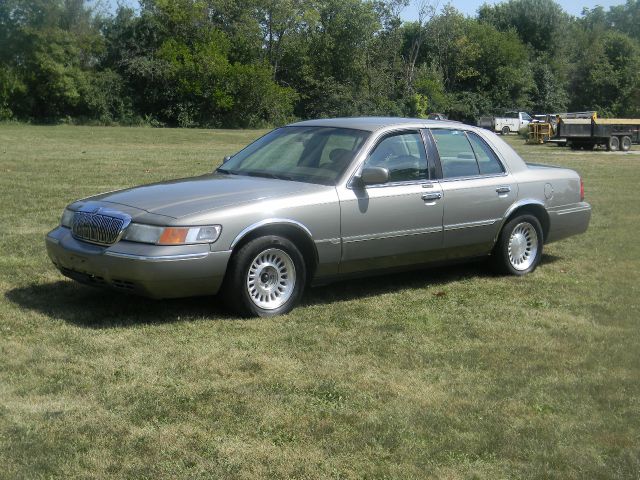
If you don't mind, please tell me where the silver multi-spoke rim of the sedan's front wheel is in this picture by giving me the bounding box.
[247,248,296,310]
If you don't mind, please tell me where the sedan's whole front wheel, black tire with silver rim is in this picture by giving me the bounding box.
[220,235,307,317]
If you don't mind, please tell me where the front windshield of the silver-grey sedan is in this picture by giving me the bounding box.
[218,127,370,185]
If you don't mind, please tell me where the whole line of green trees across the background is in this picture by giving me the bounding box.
[0,0,640,128]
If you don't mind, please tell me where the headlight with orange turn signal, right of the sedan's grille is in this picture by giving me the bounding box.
[122,223,222,245]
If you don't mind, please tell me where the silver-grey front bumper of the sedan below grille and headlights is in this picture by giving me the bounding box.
[46,227,231,298]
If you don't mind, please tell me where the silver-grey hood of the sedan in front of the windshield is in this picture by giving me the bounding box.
[80,173,327,218]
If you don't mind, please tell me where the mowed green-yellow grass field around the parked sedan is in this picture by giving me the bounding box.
[0,125,640,479]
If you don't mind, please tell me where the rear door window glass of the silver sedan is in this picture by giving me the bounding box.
[431,129,504,178]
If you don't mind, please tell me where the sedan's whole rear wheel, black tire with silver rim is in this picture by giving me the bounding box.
[491,214,543,276]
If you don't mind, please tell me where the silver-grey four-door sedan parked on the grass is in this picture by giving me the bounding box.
[46,118,591,316]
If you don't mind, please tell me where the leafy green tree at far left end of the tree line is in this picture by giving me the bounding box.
[0,0,109,120]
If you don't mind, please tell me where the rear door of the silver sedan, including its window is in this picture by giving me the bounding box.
[429,129,518,258]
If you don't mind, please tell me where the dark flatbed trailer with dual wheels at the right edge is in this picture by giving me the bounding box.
[553,115,640,152]
